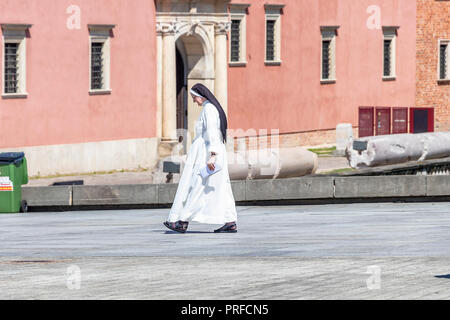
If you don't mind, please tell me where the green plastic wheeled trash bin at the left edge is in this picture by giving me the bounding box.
[0,152,28,213]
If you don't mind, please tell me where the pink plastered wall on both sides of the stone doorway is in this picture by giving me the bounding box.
[0,0,416,148]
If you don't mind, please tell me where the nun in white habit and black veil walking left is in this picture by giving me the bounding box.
[164,83,237,233]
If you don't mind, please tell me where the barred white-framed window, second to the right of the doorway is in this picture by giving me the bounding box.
[264,4,285,65]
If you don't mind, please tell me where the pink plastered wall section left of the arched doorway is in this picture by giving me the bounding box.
[0,0,156,148]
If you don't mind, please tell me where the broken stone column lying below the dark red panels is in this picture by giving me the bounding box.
[346,132,450,168]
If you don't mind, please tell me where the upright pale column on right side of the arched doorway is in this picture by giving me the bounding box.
[214,22,230,114]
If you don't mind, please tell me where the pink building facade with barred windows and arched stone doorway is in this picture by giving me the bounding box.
[0,0,420,176]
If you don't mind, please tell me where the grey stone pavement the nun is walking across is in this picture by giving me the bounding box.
[0,202,450,299]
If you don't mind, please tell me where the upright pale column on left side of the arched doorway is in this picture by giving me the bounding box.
[162,23,177,141]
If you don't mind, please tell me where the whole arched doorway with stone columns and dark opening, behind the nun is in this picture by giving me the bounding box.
[156,16,229,157]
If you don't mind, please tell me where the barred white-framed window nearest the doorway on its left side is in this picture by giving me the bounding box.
[88,24,114,94]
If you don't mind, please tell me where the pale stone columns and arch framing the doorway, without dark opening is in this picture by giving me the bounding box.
[156,0,230,157]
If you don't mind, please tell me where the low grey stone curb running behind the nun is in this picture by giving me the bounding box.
[22,175,450,208]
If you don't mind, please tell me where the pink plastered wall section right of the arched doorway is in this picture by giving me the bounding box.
[228,0,416,133]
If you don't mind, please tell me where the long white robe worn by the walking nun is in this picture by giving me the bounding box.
[168,101,237,224]
